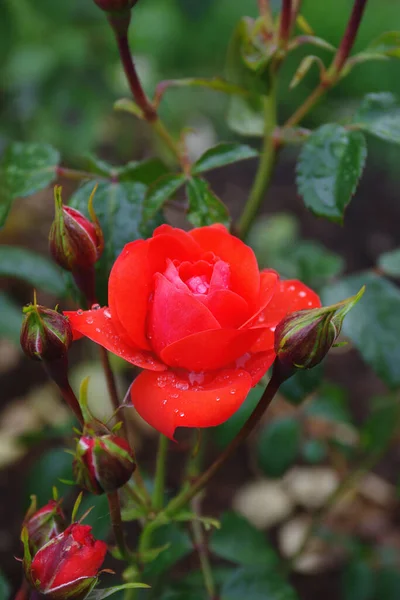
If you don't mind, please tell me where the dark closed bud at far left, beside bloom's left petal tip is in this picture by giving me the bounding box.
[20,300,72,362]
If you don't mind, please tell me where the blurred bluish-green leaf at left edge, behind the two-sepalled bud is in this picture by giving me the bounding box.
[0,246,68,297]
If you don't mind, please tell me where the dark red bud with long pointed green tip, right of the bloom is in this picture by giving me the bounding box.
[275,287,365,378]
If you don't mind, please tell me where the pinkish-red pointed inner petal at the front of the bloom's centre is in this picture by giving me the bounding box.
[148,273,221,354]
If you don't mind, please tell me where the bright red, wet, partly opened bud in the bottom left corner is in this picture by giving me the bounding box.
[25,523,107,600]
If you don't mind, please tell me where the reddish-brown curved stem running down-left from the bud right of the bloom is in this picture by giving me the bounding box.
[164,367,282,516]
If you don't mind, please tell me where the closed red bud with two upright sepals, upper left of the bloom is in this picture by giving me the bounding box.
[49,187,104,273]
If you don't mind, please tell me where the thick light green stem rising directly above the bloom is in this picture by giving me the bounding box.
[237,83,277,239]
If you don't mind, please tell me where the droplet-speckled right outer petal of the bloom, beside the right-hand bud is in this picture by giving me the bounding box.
[251,279,321,352]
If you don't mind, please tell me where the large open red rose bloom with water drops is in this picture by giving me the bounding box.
[66,225,320,438]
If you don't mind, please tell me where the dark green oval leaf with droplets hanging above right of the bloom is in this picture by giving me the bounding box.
[297,123,367,223]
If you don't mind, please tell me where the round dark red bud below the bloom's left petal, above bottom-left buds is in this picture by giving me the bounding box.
[73,434,136,494]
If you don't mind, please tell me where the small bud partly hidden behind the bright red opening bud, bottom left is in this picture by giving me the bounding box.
[24,497,66,554]
